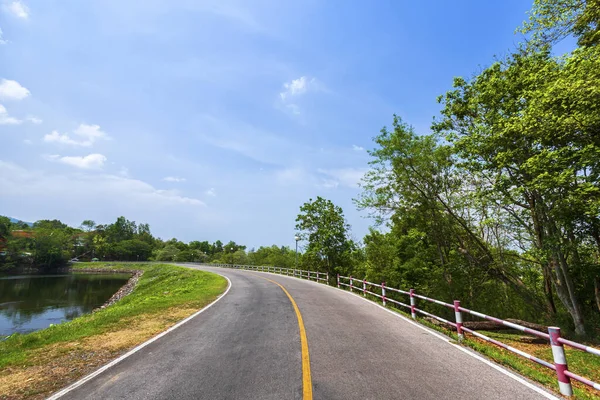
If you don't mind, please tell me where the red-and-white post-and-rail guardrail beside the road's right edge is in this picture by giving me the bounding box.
[337,275,600,396]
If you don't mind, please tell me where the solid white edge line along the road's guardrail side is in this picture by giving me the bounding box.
[210,267,560,400]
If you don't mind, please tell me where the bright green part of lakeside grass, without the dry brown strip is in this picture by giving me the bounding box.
[0,263,227,371]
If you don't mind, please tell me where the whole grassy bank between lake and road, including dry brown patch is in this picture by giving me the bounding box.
[0,263,227,399]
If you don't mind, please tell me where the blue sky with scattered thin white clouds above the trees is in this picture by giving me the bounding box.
[0,0,532,247]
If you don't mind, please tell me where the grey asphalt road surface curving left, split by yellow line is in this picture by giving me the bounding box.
[57,267,556,400]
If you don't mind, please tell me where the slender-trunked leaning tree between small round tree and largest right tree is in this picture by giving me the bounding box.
[357,116,541,318]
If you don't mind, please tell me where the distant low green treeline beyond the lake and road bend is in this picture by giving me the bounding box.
[0,216,295,270]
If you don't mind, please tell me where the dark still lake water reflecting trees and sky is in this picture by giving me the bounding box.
[0,273,130,338]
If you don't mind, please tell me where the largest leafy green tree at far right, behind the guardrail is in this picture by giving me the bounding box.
[434,47,600,334]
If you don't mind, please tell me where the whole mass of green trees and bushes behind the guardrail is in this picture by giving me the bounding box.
[296,0,600,343]
